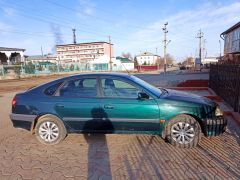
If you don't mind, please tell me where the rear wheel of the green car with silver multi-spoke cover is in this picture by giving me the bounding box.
[34,115,67,145]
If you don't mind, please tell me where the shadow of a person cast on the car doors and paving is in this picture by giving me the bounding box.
[83,108,114,179]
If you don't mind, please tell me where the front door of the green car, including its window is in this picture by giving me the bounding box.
[100,77,160,132]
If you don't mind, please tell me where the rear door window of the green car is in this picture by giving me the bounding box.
[59,78,97,98]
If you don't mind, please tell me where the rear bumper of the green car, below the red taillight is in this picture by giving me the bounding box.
[9,113,37,130]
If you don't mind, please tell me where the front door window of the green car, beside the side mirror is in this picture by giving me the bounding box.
[101,78,140,99]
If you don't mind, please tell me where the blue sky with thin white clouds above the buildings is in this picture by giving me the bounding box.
[0,0,240,61]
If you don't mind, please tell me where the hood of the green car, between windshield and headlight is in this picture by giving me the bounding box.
[164,89,216,107]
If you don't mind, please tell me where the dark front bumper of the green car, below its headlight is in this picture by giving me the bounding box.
[204,116,227,136]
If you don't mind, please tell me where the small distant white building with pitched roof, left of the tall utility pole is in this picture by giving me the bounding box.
[136,52,160,65]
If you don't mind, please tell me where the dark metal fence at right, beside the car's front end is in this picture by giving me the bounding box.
[209,64,240,112]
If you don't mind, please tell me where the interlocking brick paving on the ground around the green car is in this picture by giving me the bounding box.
[0,93,240,180]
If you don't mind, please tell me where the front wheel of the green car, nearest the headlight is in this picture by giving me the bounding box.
[164,114,202,148]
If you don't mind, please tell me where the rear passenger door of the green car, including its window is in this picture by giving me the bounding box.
[55,77,103,132]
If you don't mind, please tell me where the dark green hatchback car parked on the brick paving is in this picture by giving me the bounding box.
[10,73,226,148]
